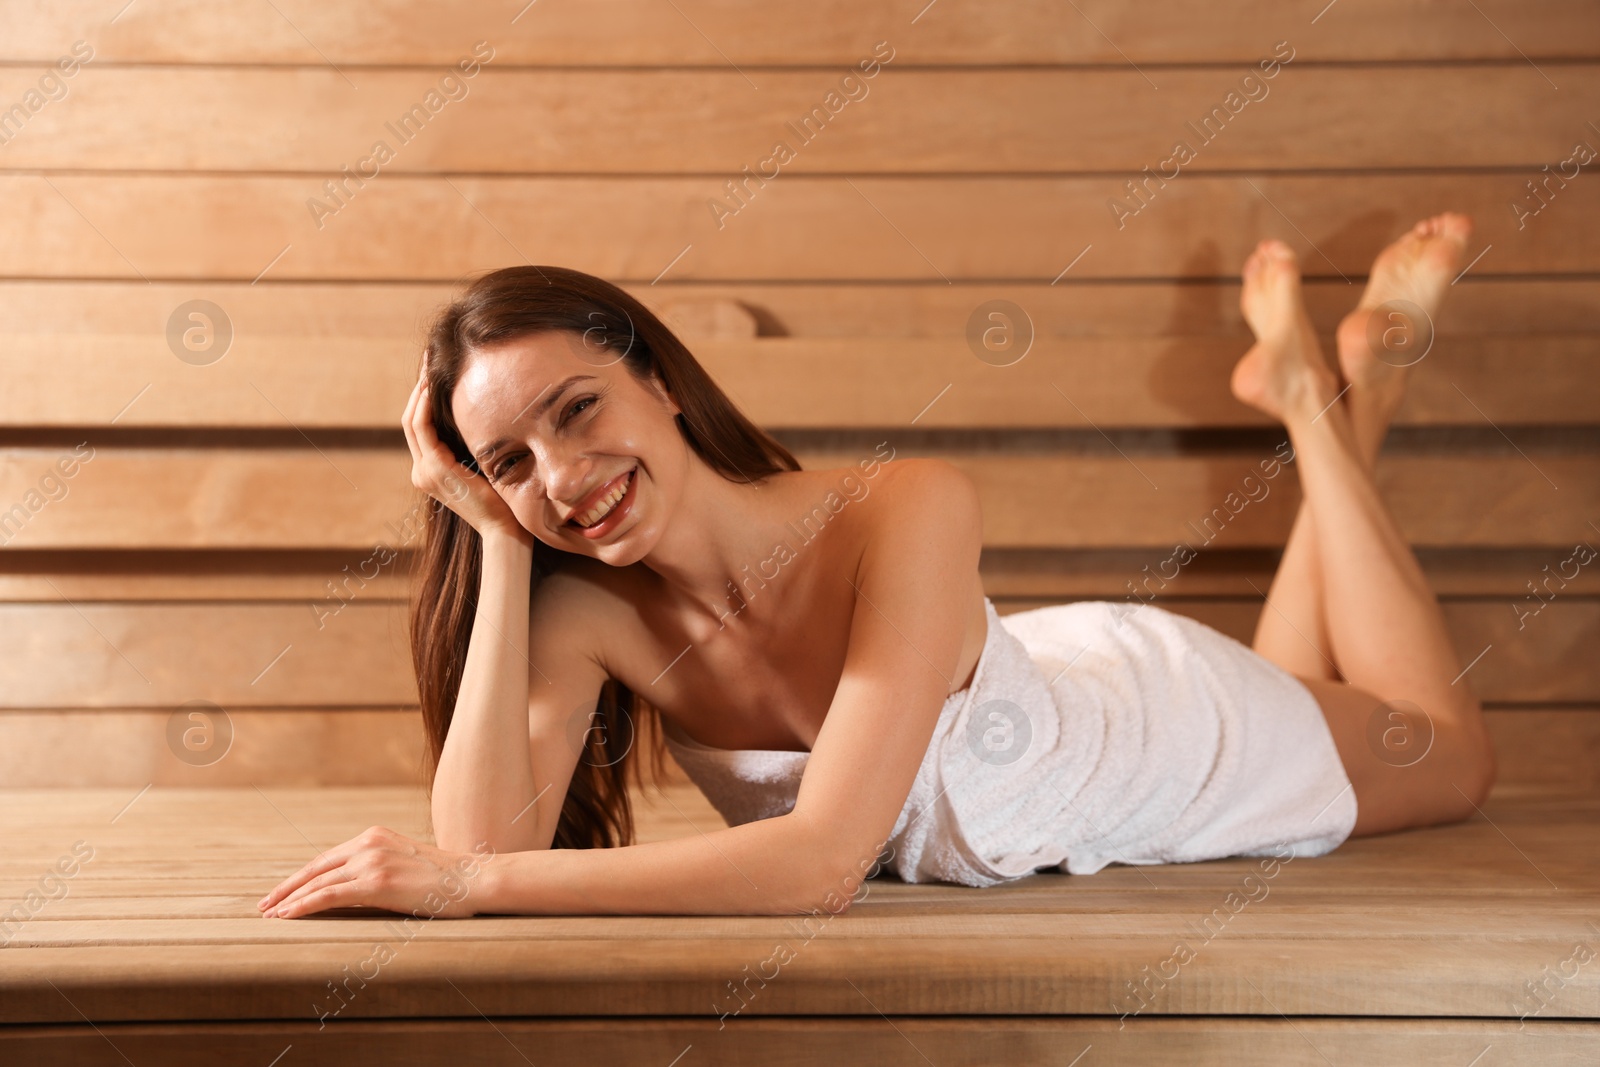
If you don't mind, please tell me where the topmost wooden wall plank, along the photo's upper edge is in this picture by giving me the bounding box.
[0,0,1600,64]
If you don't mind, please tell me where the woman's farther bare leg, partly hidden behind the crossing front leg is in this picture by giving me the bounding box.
[1246,214,1470,680]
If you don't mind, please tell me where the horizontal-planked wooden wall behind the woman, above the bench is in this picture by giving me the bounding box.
[0,0,1600,789]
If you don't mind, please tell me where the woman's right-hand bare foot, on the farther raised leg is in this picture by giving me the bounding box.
[1338,211,1472,438]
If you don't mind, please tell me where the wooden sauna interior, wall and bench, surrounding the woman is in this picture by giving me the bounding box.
[0,0,1600,1067]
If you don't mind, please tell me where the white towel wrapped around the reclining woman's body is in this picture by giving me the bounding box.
[666,598,1355,886]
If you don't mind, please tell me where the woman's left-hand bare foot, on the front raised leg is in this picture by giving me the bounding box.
[1230,240,1339,422]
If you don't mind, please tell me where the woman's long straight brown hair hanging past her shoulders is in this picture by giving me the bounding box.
[411,266,800,848]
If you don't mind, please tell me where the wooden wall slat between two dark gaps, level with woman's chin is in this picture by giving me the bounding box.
[0,446,1600,550]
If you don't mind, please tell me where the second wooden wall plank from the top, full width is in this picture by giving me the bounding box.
[0,64,1600,173]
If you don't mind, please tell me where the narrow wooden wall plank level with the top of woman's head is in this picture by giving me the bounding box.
[0,279,1600,342]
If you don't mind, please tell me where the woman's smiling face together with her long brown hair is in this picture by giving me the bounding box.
[408,267,800,848]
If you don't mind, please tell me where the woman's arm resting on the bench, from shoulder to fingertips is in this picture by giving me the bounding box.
[262,461,982,917]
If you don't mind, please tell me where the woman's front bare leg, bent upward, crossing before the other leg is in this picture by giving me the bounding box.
[1232,237,1494,833]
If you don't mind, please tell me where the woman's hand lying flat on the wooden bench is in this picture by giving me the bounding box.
[256,825,494,918]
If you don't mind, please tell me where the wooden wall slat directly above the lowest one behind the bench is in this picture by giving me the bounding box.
[0,595,1600,710]
